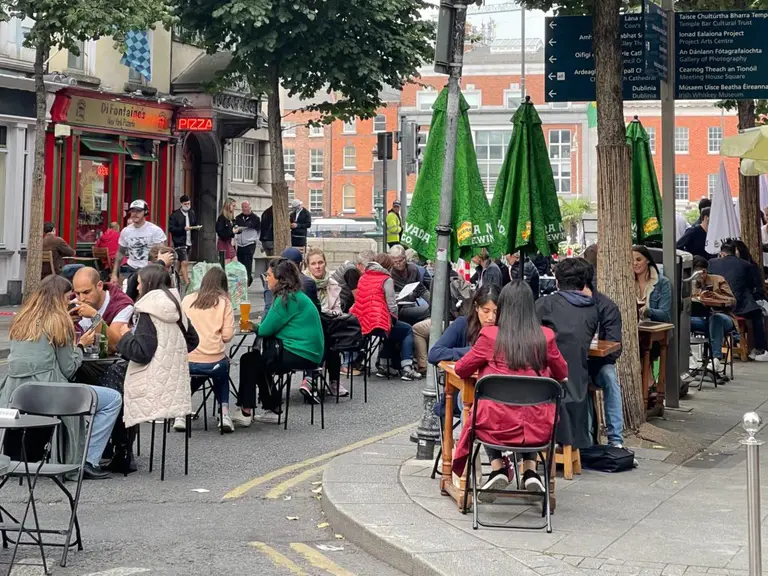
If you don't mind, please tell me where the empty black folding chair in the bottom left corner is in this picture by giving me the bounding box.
[0,382,97,567]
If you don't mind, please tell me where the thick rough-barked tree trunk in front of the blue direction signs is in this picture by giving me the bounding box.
[592,0,646,430]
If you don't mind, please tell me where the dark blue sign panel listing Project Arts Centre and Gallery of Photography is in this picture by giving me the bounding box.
[675,10,768,100]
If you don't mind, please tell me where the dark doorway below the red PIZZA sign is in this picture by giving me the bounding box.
[182,133,220,262]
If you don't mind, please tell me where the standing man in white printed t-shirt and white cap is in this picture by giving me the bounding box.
[112,200,168,283]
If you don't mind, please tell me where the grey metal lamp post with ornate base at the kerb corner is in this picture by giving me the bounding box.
[416,1,467,460]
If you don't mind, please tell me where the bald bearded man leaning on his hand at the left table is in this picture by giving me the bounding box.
[72,267,133,351]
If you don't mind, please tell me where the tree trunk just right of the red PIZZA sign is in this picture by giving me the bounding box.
[267,66,291,254]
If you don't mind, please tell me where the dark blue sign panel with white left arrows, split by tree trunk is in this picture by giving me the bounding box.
[544,14,661,102]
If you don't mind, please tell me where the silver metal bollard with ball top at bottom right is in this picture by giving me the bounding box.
[741,412,763,576]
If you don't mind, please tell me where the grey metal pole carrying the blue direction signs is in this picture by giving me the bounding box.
[661,0,688,408]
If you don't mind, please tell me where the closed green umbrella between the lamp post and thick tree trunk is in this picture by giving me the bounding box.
[491,96,565,256]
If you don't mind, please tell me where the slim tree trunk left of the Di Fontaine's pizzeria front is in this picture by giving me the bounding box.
[24,43,48,300]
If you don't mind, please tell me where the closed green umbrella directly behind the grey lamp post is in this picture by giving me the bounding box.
[401,89,495,262]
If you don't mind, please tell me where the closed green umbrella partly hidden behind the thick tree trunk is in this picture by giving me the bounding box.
[627,116,662,244]
